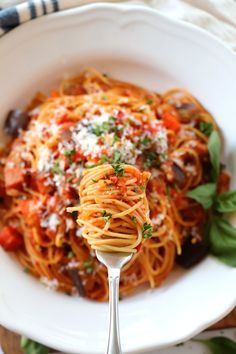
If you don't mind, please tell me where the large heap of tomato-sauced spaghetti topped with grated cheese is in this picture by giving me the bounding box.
[0,69,229,301]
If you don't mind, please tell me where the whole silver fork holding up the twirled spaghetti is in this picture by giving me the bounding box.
[96,251,132,354]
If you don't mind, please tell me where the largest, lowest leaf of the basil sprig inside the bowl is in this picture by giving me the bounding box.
[209,216,236,267]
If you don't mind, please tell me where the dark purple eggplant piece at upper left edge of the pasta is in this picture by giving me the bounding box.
[4,109,29,137]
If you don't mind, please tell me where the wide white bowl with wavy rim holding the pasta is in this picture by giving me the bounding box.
[0,4,236,354]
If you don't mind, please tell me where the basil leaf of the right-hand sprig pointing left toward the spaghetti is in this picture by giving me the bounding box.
[186,183,216,209]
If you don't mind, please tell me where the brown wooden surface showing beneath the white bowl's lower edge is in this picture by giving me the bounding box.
[0,309,236,354]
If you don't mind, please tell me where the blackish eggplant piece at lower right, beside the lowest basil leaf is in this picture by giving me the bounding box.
[176,237,209,269]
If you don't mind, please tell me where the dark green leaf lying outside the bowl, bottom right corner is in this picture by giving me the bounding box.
[198,337,236,354]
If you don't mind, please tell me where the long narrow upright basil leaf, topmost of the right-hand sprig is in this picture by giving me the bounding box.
[208,131,221,182]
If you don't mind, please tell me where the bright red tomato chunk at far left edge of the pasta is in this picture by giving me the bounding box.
[0,226,24,252]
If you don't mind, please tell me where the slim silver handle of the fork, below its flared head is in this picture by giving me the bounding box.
[106,268,122,354]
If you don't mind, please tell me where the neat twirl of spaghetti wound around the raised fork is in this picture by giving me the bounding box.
[67,164,152,253]
